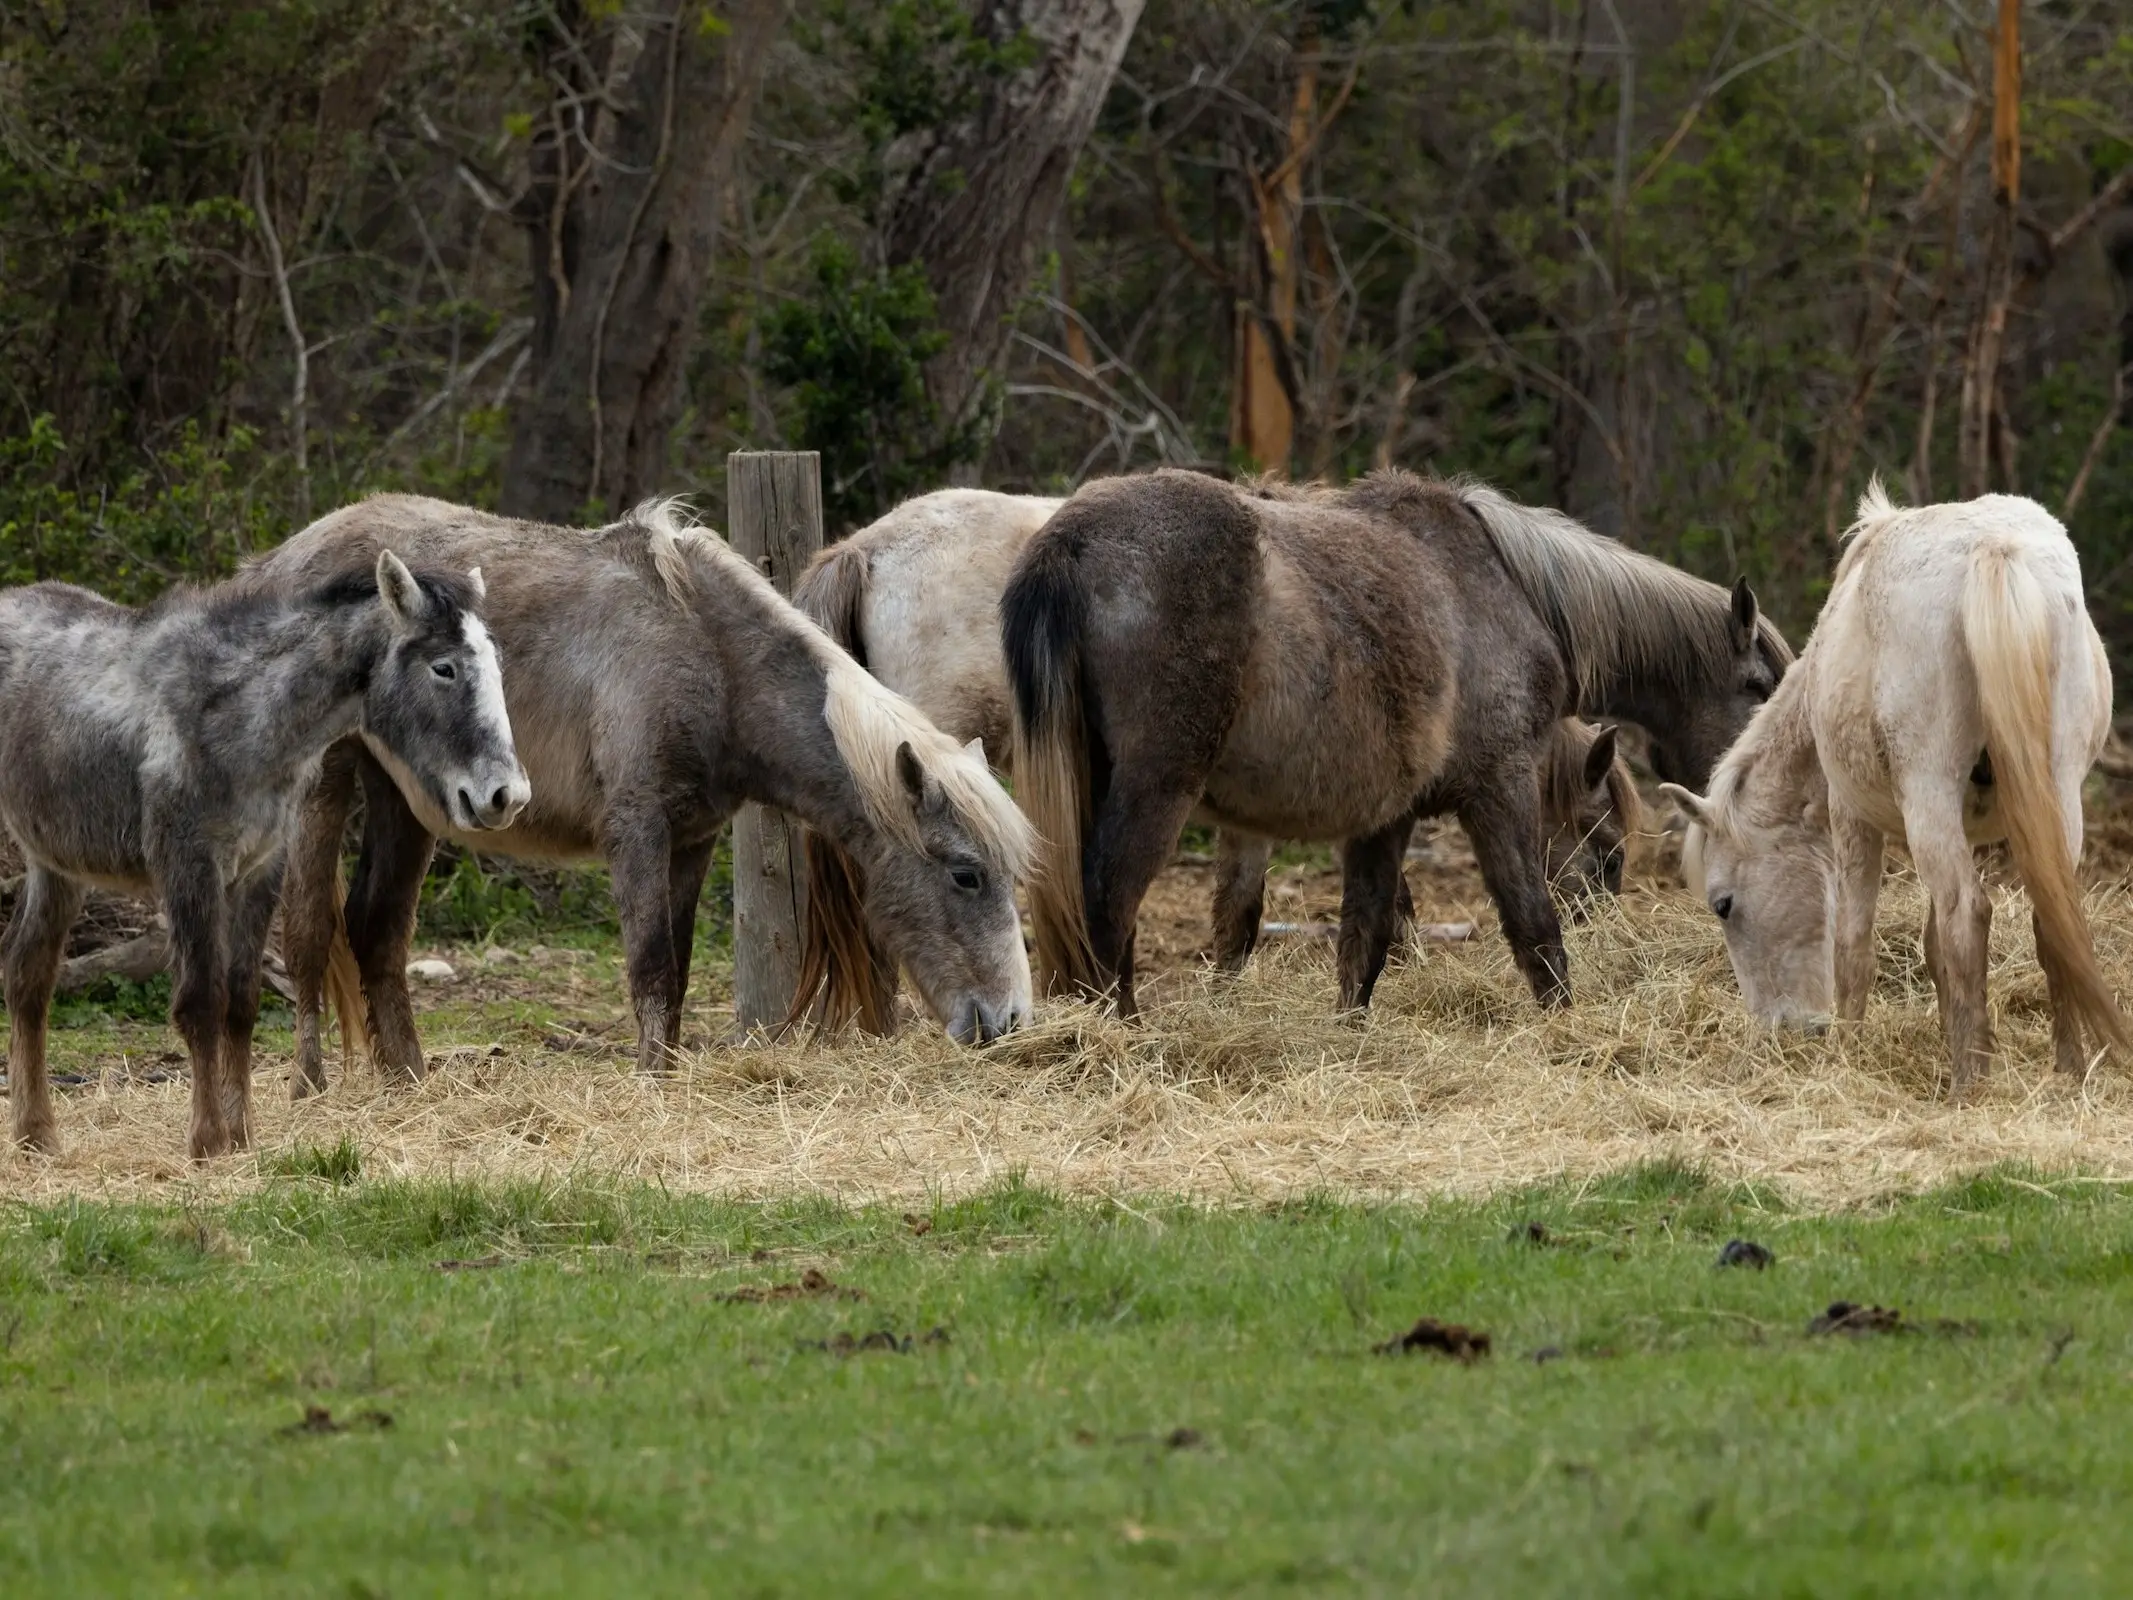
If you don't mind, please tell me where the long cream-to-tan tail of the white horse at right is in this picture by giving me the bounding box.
[1962,544,2127,1050]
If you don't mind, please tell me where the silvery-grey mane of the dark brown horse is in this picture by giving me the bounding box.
[1424,471,1792,700]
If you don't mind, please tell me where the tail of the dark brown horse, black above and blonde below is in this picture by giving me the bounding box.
[1000,535,1098,994]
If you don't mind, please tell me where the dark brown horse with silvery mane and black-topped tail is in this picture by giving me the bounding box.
[1000,469,1790,1013]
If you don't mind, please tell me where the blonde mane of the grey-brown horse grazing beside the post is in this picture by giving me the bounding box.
[610,497,1037,879]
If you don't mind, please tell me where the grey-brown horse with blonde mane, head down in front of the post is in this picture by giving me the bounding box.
[264,495,1032,1094]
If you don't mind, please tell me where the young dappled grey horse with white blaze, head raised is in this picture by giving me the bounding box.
[0,548,529,1161]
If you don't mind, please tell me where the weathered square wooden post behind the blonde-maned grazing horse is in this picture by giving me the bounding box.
[725,450,821,1033]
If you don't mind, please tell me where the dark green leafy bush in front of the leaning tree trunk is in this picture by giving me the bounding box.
[764,235,983,529]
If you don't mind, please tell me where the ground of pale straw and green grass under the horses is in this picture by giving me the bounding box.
[12,840,2133,1596]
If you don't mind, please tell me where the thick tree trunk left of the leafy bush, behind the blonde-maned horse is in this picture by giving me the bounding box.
[501,0,785,523]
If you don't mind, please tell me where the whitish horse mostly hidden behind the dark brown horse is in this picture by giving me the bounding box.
[793,489,1640,1026]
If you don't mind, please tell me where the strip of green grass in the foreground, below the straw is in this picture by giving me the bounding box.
[0,1150,2133,1596]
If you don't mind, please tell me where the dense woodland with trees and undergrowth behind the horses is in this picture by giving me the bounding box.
[0,0,2133,659]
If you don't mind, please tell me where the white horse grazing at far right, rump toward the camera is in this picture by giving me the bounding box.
[1662,480,2127,1099]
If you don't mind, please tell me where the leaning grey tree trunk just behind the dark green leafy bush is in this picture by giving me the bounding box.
[881,0,1143,460]
